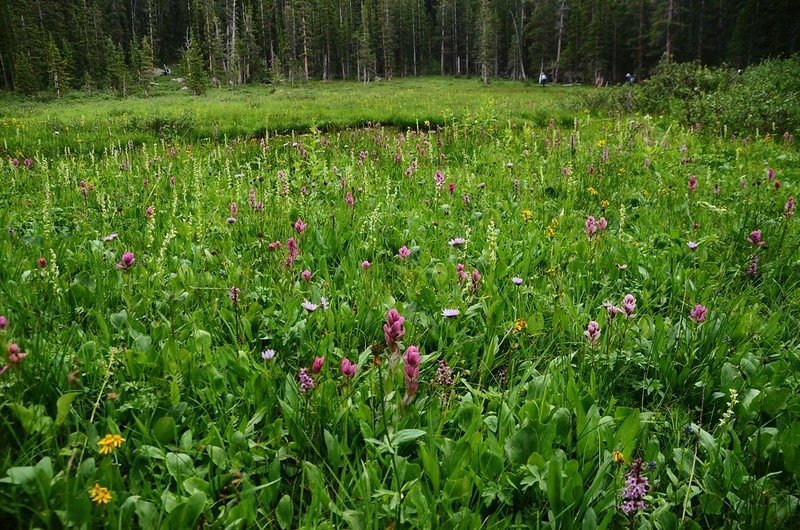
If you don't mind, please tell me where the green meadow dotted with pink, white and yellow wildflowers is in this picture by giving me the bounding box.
[0,79,800,529]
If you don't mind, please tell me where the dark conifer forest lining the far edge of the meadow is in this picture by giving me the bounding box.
[0,0,800,95]
